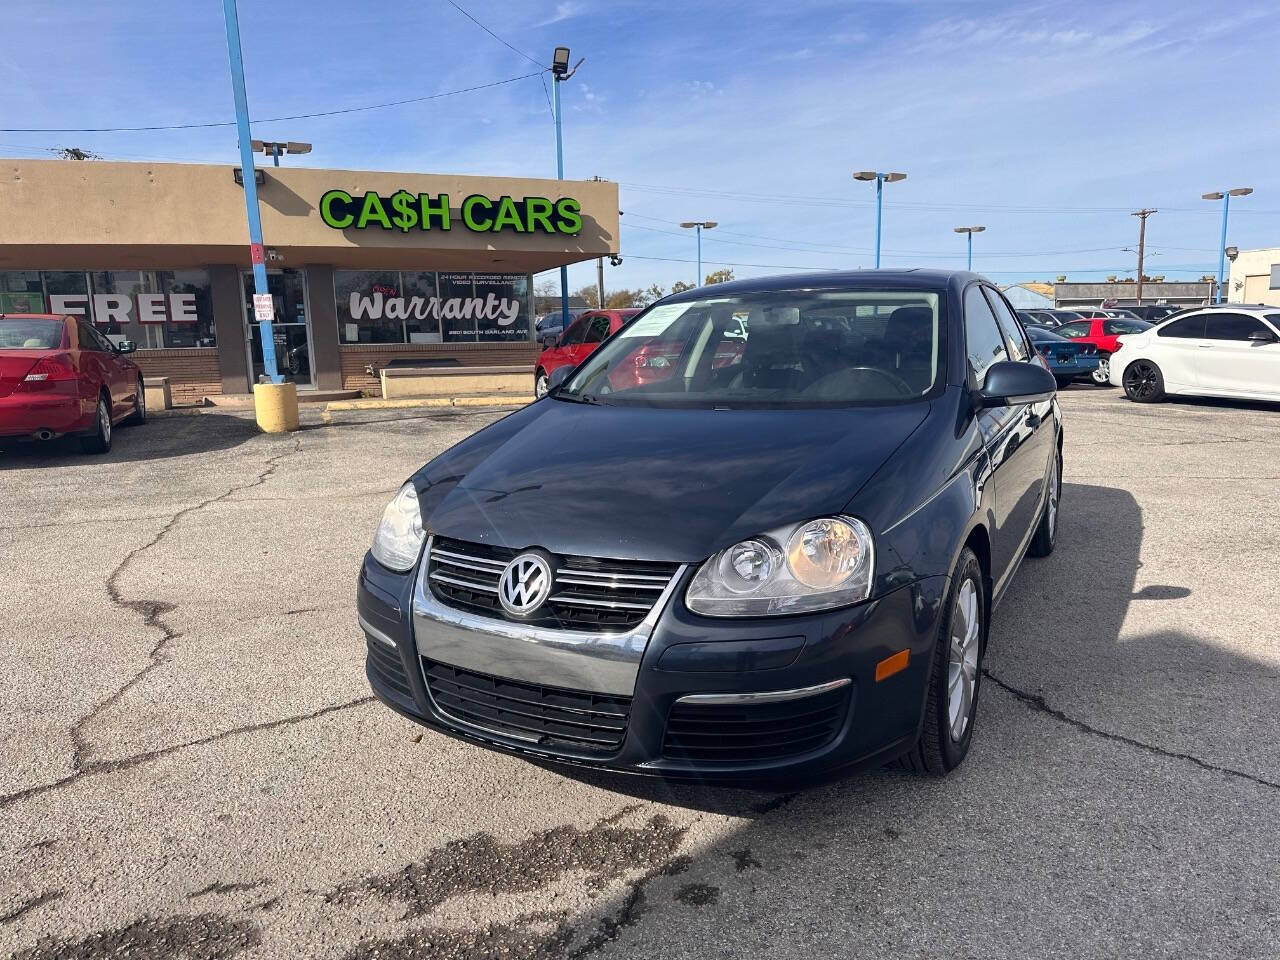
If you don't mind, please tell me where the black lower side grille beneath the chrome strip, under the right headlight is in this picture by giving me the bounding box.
[662,685,850,765]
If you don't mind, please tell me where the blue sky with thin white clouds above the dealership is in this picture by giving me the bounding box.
[0,0,1280,293]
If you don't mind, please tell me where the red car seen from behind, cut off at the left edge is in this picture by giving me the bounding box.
[0,314,147,453]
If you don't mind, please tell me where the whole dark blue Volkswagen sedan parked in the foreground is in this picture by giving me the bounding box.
[357,270,1062,782]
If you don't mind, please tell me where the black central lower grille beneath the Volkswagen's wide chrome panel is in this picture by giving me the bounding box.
[422,658,631,754]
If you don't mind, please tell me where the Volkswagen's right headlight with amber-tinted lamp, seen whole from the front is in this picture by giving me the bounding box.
[685,517,876,617]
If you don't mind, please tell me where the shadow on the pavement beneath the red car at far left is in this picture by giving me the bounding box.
[0,413,260,470]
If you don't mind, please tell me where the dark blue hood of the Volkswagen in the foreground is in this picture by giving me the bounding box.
[419,398,929,563]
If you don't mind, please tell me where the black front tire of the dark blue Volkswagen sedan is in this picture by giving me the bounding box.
[899,547,987,777]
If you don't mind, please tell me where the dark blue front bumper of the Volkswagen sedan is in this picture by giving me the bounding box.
[357,554,947,781]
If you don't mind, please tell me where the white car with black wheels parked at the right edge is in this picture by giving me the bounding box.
[1110,303,1280,403]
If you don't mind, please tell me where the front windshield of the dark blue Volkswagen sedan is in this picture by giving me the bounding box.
[556,289,943,407]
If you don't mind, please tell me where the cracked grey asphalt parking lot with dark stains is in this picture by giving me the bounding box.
[0,387,1280,960]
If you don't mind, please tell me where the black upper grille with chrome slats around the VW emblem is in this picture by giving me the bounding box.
[426,538,680,631]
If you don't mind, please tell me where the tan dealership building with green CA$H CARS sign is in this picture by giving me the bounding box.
[0,160,618,402]
